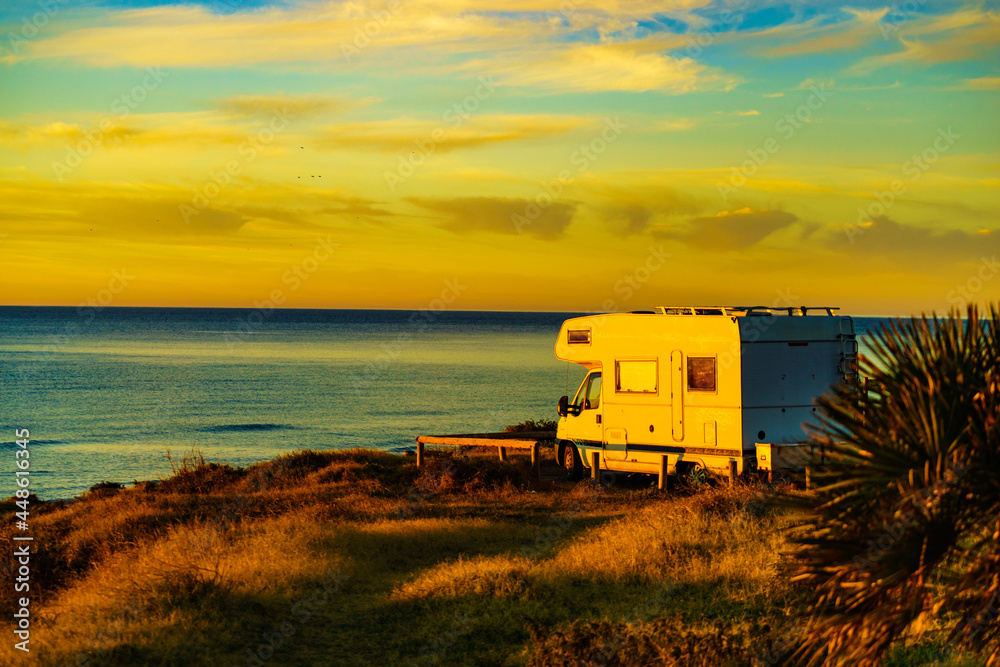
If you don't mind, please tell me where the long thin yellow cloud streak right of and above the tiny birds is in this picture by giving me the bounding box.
[314,113,592,153]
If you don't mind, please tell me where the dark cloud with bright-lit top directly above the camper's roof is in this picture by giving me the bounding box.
[658,208,799,250]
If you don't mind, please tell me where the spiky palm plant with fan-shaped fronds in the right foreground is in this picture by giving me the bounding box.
[789,305,1000,665]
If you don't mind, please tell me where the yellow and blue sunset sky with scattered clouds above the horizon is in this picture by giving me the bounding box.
[0,0,1000,315]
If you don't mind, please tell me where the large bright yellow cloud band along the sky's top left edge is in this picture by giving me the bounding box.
[5,0,688,68]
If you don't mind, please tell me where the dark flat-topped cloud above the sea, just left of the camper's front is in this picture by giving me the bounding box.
[408,197,576,240]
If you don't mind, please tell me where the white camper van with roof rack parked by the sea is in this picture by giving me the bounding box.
[555,306,858,481]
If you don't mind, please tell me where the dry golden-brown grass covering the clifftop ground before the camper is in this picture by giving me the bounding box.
[0,450,976,665]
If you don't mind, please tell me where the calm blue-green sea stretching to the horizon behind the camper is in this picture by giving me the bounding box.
[0,306,879,500]
